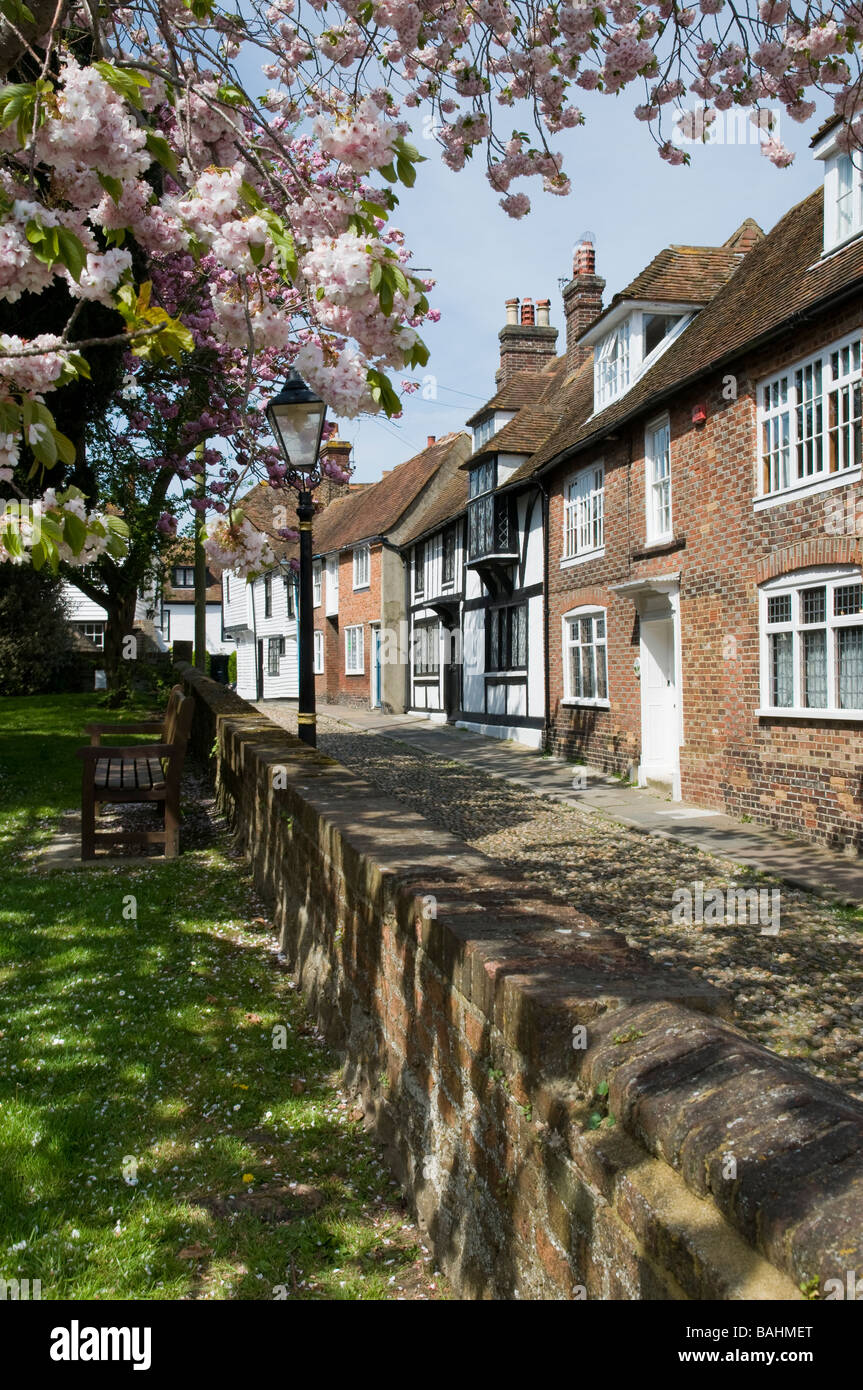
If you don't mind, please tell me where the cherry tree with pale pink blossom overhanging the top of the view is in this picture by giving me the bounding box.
[0,0,863,573]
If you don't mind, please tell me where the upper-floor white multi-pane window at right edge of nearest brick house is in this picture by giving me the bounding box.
[755,329,863,510]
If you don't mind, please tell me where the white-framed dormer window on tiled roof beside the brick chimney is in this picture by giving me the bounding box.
[581,302,692,411]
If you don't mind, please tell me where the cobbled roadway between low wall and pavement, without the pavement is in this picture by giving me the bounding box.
[261,706,863,1099]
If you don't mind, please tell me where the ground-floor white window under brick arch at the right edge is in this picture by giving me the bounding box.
[757,564,863,723]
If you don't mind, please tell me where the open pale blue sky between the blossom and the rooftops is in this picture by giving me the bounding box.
[340,93,828,482]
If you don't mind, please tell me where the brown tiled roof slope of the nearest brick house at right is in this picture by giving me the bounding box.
[528,188,863,481]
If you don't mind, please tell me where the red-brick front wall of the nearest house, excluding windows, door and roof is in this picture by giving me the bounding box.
[548,300,863,849]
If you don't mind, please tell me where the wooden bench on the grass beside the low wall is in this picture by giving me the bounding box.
[78,685,195,859]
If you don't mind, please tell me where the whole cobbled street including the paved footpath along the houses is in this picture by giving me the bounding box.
[257,701,863,1099]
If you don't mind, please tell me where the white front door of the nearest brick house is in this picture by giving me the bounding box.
[639,617,680,794]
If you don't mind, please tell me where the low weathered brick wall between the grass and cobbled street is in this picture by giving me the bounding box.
[185,670,863,1300]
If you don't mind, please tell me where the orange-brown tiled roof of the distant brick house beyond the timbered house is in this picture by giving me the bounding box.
[313,431,468,555]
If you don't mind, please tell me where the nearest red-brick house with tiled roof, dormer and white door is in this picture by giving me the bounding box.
[529,152,863,849]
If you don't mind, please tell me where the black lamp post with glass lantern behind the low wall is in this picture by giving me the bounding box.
[267,371,327,748]
